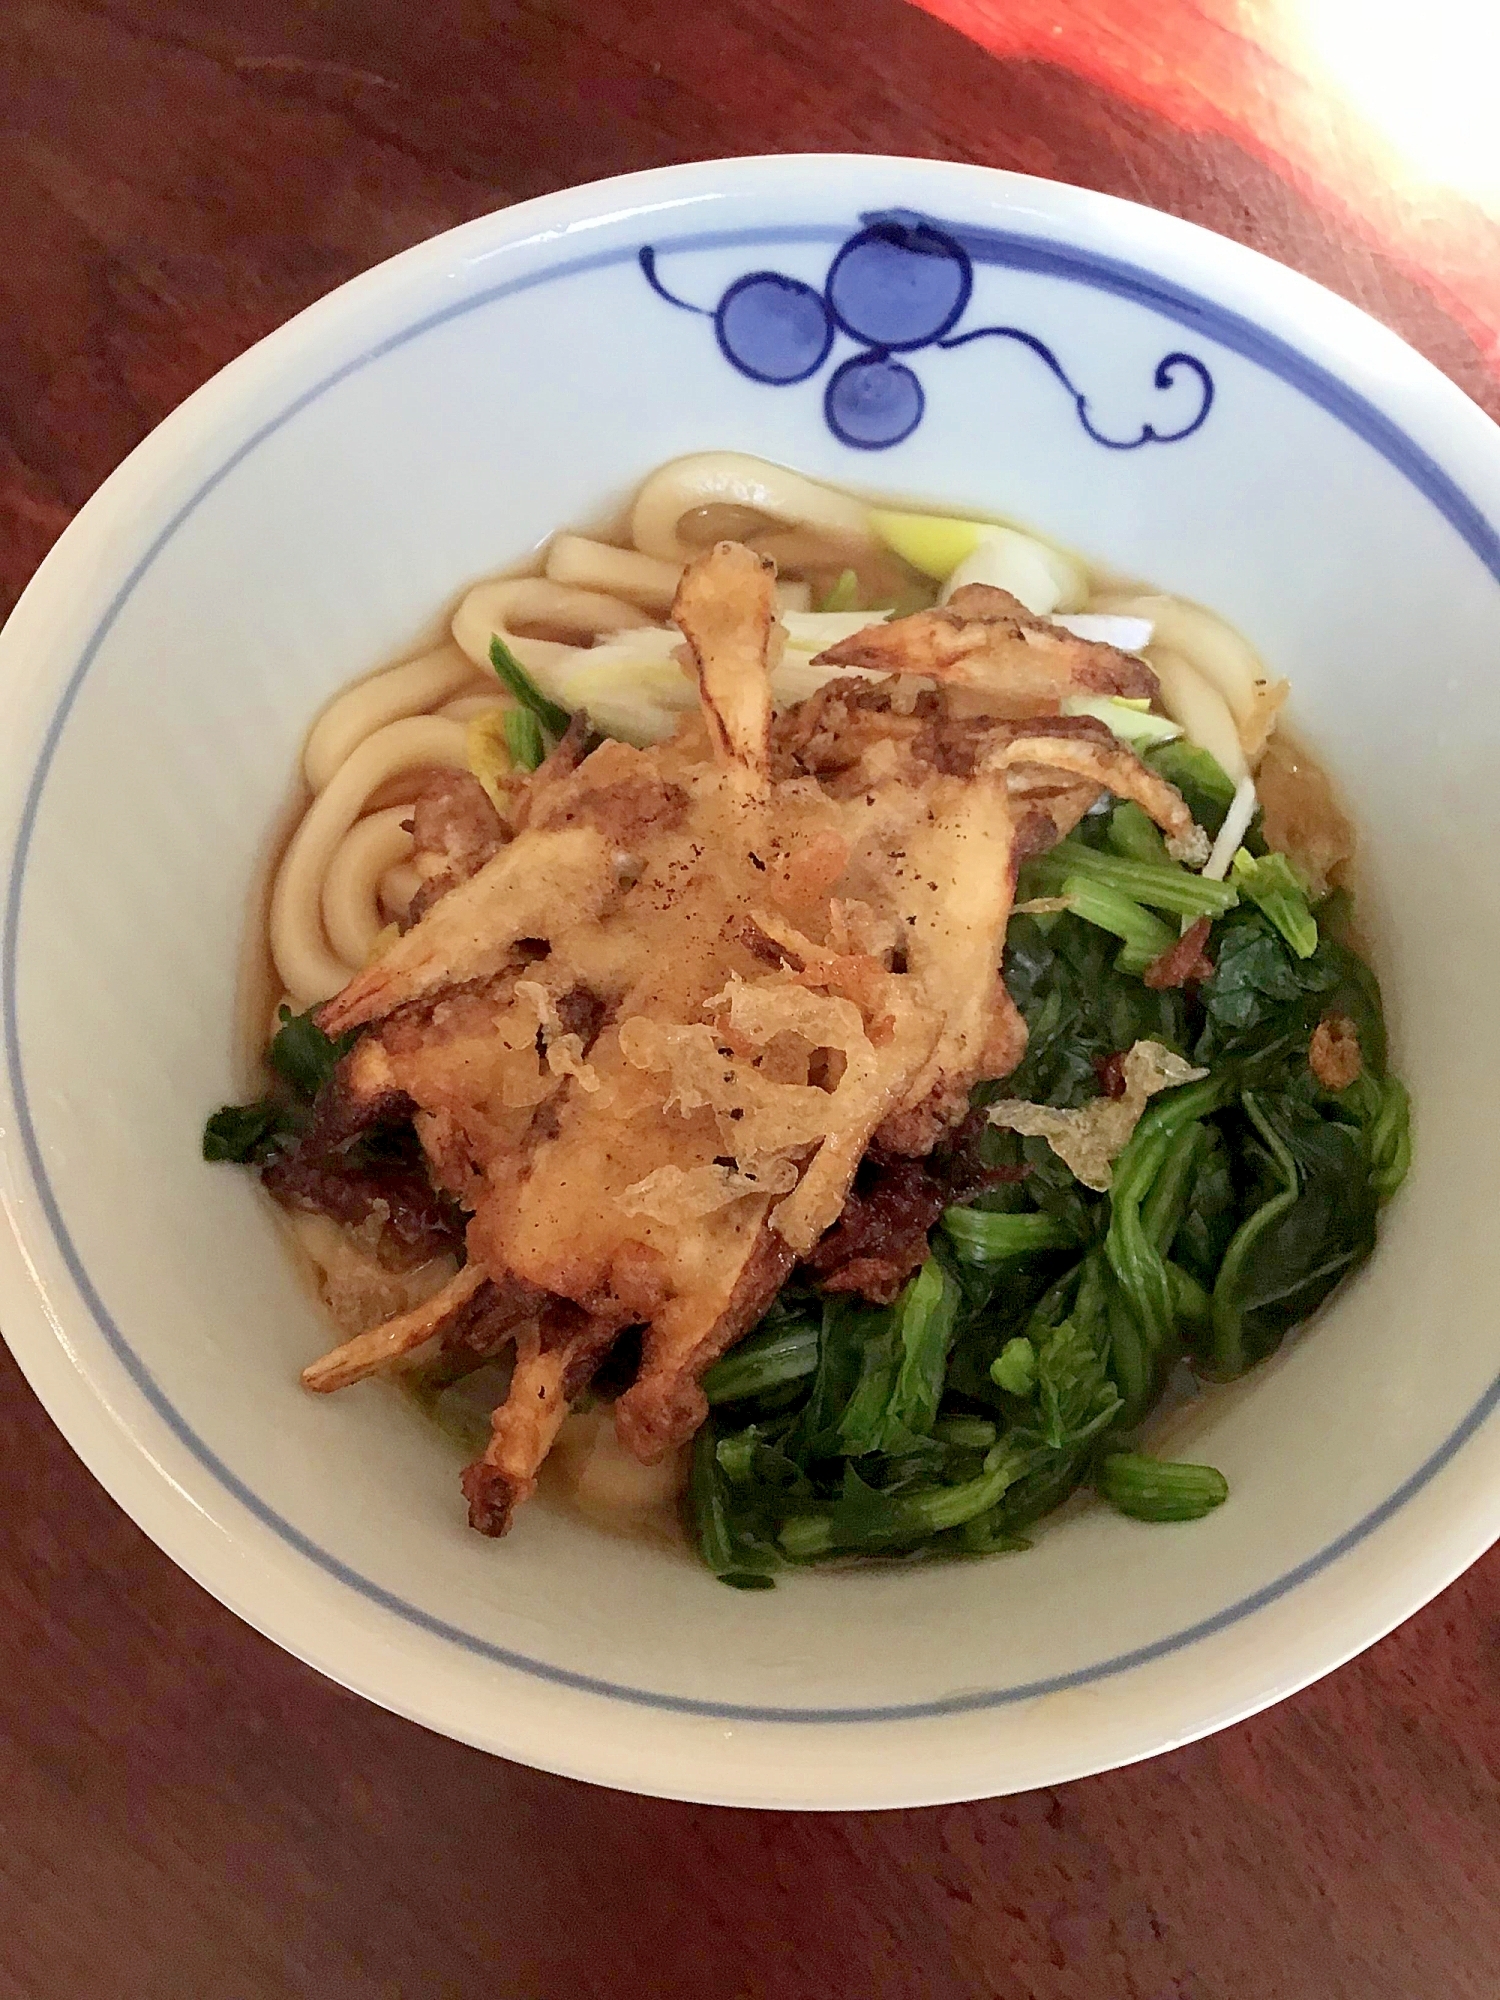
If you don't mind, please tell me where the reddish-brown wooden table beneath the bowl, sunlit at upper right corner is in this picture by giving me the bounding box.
[0,0,1500,2000]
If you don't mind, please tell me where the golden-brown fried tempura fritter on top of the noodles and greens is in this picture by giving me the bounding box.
[304,542,1196,1534]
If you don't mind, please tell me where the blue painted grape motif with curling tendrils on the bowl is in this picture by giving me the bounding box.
[640,214,1214,452]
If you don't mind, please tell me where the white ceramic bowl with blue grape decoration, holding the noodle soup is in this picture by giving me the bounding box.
[0,158,1500,1806]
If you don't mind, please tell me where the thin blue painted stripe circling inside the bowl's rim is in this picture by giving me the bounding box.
[0,218,1500,1724]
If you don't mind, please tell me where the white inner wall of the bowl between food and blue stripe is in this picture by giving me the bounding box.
[5,203,1500,1712]
